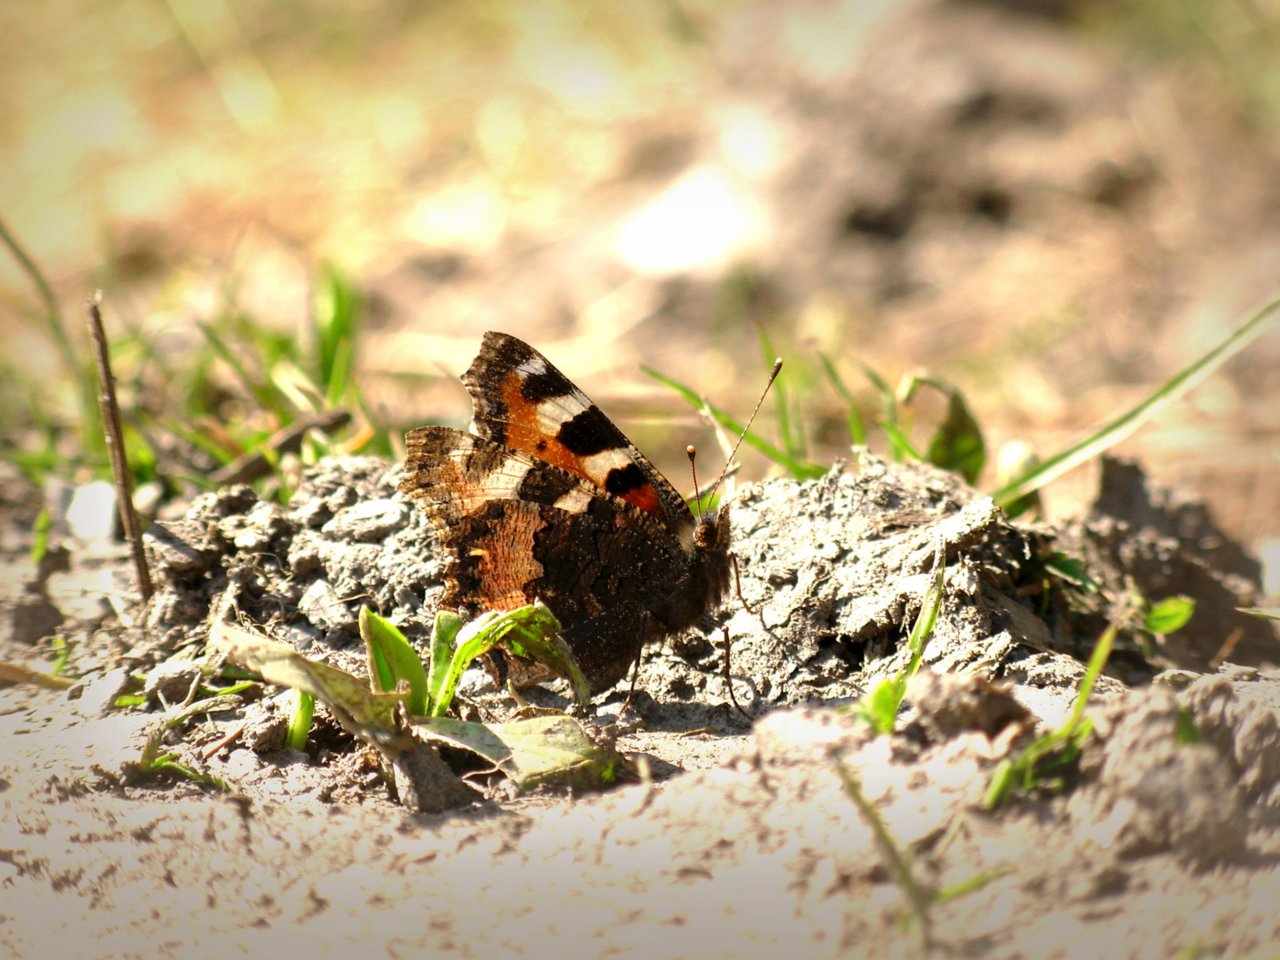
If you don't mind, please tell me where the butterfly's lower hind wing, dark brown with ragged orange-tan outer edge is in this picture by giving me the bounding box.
[399,426,684,691]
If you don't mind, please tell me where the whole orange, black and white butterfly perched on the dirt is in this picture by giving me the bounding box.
[401,332,730,691]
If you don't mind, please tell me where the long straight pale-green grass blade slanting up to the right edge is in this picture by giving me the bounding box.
[992,297,1280,507]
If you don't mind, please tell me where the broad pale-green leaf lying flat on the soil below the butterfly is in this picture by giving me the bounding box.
[413,714,620,790]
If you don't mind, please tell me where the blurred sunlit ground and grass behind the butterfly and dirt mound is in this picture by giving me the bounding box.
[0,0,1280,570]
